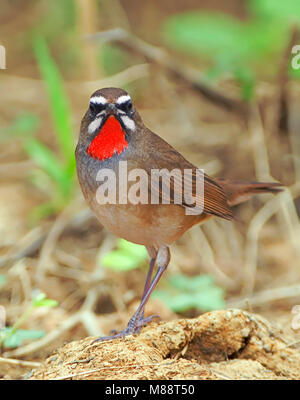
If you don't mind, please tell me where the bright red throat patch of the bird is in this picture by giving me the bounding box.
[87,115,128,161]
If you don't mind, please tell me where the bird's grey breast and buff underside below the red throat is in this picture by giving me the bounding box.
[76,147,204,246]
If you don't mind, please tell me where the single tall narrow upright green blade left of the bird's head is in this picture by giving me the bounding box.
[34,37,75,170]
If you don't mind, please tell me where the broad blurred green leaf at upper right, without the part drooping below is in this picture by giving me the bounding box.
[163,12,285,61]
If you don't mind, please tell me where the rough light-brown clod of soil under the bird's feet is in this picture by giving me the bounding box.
[30,309,300,379]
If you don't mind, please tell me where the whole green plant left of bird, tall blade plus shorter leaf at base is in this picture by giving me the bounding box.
[24,36,75,218]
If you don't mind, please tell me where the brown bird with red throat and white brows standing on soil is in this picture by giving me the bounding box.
[75,87,282,341]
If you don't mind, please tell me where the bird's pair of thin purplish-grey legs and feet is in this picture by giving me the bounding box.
[93,246,170,343]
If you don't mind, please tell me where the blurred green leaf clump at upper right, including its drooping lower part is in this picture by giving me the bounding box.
[163,10,290,84]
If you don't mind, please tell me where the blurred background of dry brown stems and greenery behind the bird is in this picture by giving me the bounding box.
[0,0,300,376]
